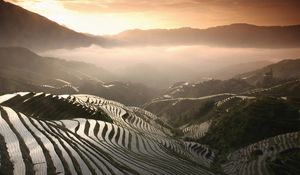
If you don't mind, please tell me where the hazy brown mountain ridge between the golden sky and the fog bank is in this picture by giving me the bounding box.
[0,1,300,51]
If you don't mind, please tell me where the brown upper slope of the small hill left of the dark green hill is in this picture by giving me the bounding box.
[143,94,232,127]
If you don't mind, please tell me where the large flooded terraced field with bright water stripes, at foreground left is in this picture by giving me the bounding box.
[0,92,214,175]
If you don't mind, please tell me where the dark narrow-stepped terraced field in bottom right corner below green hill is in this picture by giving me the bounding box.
[222,132,300,175]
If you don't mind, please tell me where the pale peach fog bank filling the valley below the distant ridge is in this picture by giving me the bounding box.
[39,45,300,87]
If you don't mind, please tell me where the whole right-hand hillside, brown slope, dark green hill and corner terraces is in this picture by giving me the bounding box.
[144,91,300,175]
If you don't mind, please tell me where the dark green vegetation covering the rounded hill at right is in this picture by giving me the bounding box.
[201,97,300,153]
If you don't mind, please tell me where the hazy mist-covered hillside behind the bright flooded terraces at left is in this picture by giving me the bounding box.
[0,47,156,105]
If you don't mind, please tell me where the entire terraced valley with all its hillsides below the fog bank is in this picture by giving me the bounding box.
[0,47,300,175]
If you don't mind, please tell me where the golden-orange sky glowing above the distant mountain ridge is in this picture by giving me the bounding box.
[7,0,300,35]
